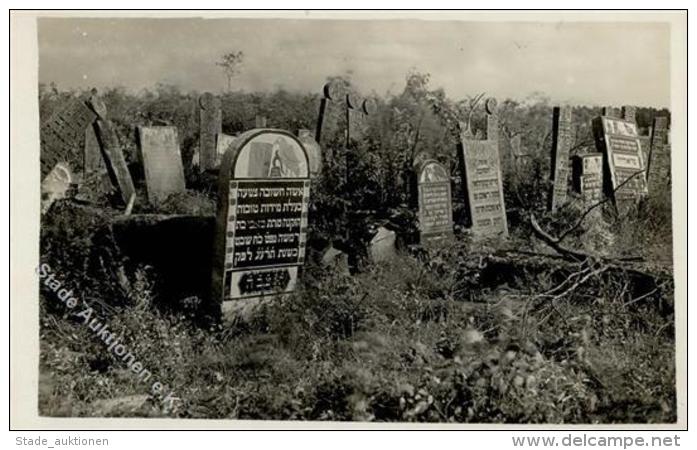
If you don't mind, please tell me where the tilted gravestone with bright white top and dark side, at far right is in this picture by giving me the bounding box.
[593,116,647,206]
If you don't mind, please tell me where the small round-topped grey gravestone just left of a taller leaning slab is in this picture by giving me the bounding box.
[417,160,453,245]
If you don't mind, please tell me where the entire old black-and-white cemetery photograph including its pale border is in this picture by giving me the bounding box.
[11,11,687,428]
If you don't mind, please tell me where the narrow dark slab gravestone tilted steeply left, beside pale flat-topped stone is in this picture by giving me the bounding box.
[89,95,136,205]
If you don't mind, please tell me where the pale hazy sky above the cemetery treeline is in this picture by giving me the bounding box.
[38,18,670,107]
